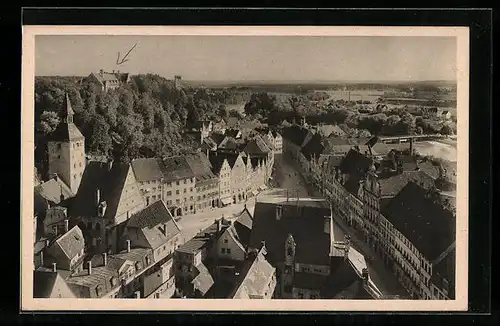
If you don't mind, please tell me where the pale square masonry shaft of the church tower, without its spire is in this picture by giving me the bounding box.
[47,138,86,194]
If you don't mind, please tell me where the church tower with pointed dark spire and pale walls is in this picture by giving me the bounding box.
[48,94,85,194]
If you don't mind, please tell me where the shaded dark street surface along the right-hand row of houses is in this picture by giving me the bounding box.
[275,156,409,299]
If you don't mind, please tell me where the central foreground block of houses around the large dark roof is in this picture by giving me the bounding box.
[174,194,384,299]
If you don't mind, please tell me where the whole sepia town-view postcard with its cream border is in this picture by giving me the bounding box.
[22,26,468,311]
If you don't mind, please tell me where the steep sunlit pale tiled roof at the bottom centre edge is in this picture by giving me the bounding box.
[232,250,276,299]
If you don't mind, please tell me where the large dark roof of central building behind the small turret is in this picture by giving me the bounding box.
[250,201,330,265]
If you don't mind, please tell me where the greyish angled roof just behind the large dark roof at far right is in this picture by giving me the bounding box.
[379,171,434,197]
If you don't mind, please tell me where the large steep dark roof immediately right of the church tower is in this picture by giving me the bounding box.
[71,162,143,219]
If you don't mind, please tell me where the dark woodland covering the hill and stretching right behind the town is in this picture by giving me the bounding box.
[35,74,453,178]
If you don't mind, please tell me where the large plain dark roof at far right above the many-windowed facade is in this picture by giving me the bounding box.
[382,182,456,261]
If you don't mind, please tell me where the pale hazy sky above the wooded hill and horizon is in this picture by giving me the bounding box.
[35,35,457,81]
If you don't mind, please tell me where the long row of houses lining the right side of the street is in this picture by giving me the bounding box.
[283,126,456,299]
